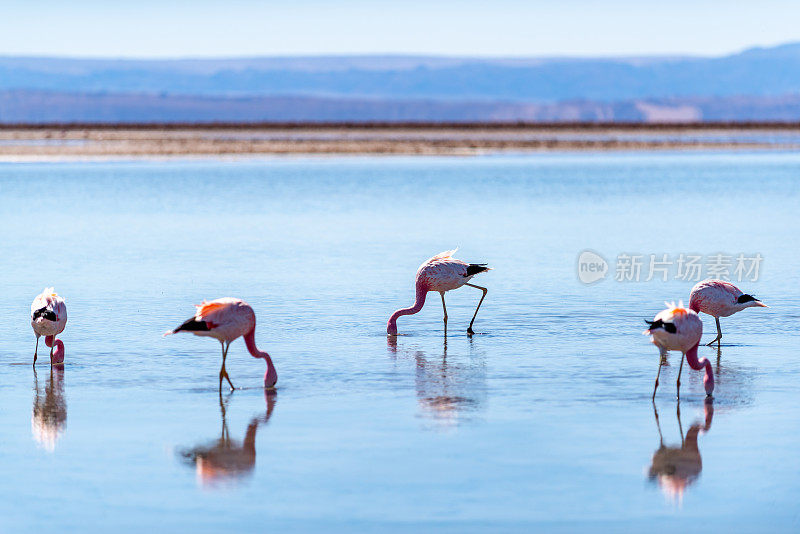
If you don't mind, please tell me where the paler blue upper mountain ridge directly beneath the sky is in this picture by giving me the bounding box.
[0,44,800,102]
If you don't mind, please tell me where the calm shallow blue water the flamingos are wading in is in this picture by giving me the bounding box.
[0,153,800,532]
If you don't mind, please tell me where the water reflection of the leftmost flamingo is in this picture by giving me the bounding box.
[31,366,67,452]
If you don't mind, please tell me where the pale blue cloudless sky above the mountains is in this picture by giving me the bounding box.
[0,0,800,57]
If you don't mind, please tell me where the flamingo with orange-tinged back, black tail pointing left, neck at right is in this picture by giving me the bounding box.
[164,297,278,390]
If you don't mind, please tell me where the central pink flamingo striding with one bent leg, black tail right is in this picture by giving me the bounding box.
[386,249,490,336]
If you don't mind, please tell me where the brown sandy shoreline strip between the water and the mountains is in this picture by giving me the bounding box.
[0,124,800,161]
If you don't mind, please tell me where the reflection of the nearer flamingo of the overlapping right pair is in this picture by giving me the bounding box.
[649,399,714,501]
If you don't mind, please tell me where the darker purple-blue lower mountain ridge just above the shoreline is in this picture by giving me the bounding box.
[6,91,800,123]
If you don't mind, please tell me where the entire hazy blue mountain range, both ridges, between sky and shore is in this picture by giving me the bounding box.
[0,43,800,122]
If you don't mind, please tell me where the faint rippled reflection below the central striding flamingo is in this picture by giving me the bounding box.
[388,336,486,430]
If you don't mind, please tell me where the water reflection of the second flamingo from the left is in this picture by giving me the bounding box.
[179,390,277,488]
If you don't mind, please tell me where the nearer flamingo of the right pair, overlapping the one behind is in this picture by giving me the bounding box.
[644,302,714,399]
